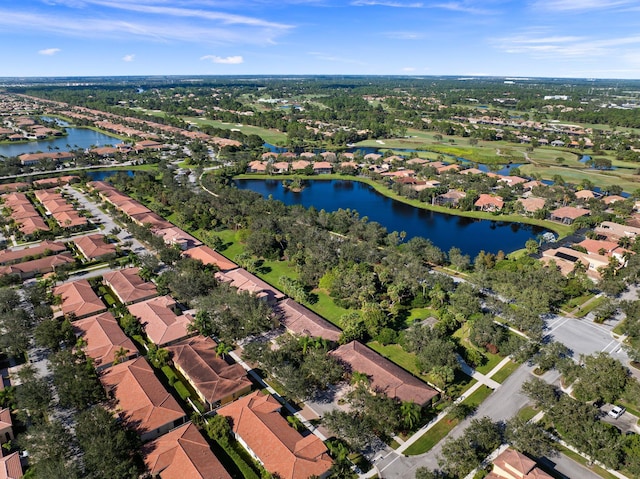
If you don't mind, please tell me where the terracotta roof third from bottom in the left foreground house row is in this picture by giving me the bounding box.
[73,312,138,369]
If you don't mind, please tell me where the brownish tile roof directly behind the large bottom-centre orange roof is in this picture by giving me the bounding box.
[167,336,252,405]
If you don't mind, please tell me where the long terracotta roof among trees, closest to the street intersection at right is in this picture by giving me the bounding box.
[329,341,438,406]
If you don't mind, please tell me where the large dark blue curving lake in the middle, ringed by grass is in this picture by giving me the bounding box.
[235,180,547,259]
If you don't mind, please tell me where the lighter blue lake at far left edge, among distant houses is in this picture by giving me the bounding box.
[0,128,121,157]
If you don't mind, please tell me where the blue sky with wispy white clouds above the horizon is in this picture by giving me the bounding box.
[0,0,640,79]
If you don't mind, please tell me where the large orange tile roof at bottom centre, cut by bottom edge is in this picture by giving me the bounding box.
[218,391,332,479]
